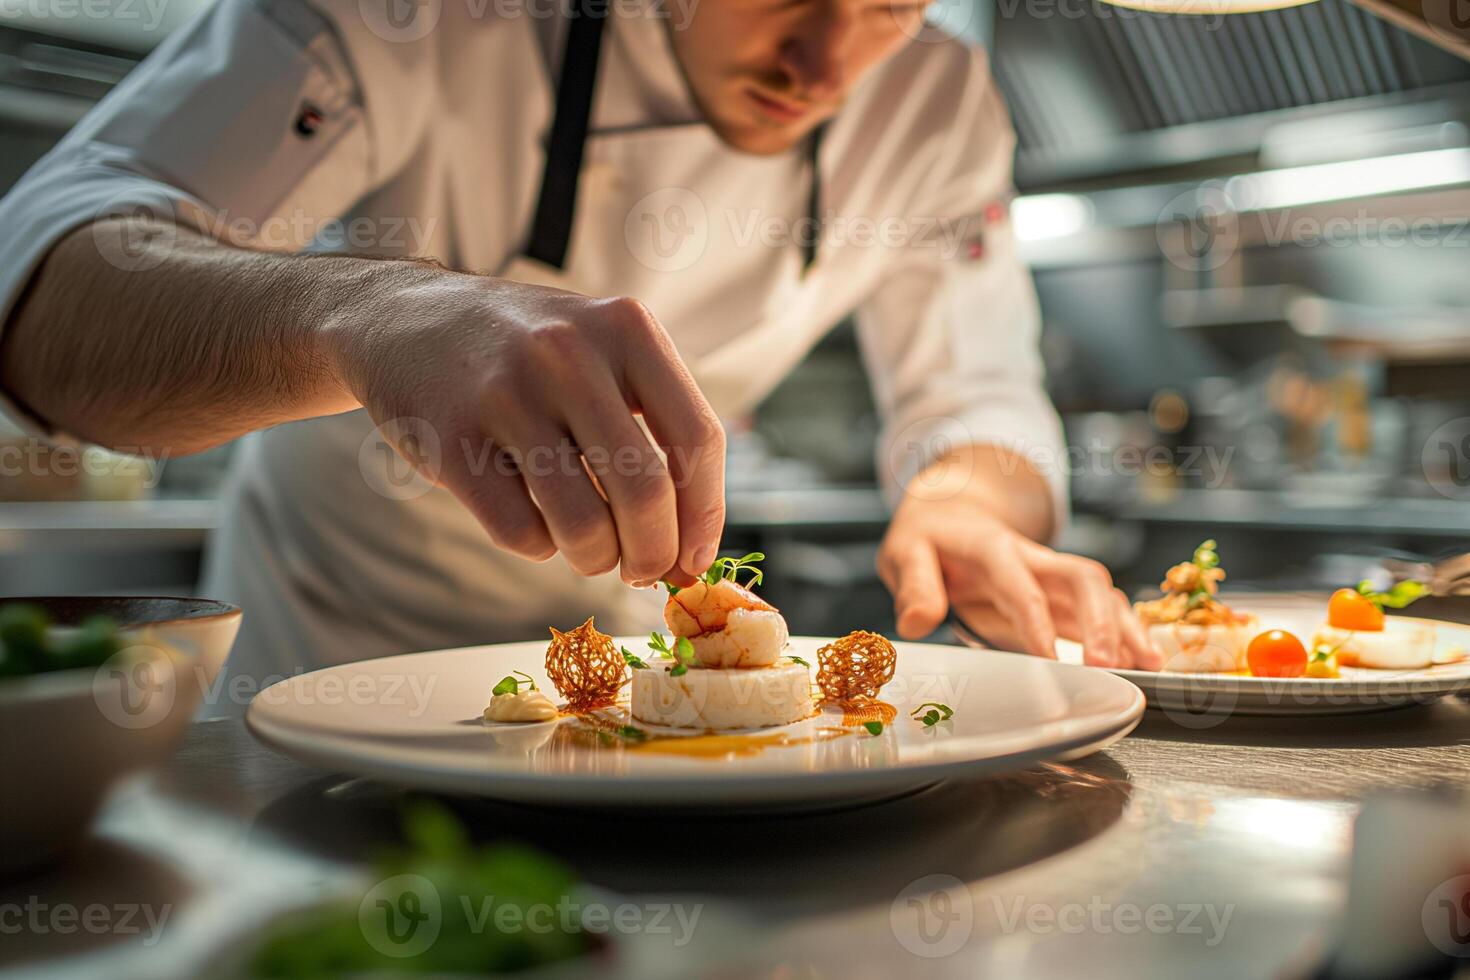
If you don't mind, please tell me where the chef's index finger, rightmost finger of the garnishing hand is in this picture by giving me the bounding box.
[611,304,725,576]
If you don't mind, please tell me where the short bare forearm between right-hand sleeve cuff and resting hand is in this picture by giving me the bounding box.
[900,444,1057,542]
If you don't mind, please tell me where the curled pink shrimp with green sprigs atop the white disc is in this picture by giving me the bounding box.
[663,555,789,667]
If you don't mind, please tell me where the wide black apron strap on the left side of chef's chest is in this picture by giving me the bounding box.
[526,0,607,269]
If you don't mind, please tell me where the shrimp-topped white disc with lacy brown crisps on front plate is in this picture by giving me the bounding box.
[484,552,954,754]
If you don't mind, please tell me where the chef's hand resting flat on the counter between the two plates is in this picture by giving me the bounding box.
[878,447,1163,670]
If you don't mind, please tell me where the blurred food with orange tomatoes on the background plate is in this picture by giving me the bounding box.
[1133,541,1440,680]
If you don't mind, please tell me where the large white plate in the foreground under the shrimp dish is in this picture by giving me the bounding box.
[245,636,1144,807]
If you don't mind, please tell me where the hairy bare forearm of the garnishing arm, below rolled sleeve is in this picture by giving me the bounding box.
[0,219,398,455]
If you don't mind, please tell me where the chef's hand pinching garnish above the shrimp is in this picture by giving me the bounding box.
[328,266,725,585]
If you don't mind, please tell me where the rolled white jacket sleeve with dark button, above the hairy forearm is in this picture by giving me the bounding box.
[0,0,372,435]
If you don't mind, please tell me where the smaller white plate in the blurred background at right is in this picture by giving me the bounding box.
[1057,595,1470,717]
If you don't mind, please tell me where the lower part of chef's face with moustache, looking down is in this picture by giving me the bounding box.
[669,0,929,153]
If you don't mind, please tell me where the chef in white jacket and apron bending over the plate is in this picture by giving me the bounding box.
[0,0,1157,713]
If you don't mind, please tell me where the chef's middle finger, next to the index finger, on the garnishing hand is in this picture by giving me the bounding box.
[566,375,679,588]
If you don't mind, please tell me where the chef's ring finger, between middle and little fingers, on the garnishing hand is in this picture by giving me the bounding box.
[496,426,620,576]
